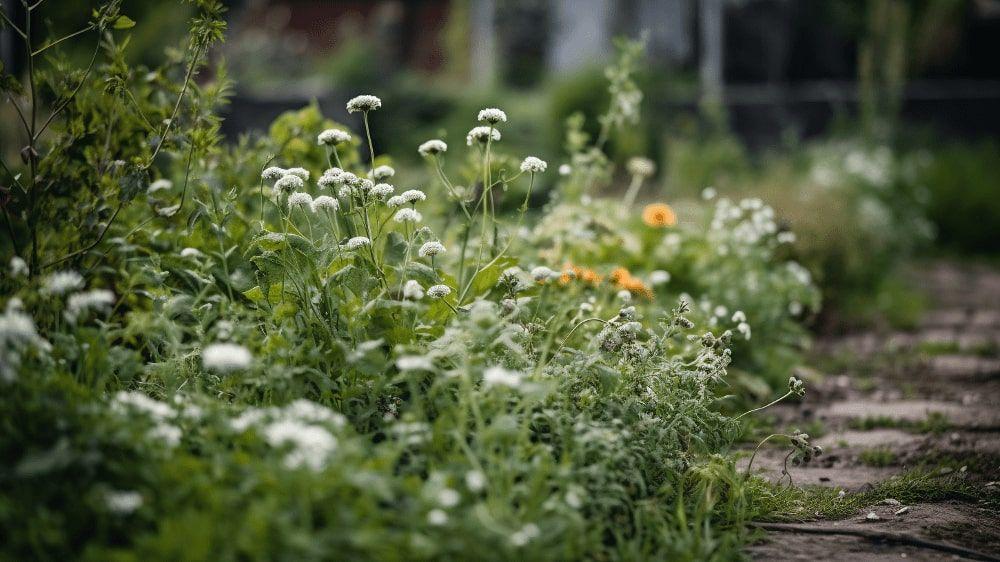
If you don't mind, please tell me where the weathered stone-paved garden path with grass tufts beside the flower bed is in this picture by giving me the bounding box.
[743,263,1000,561]
